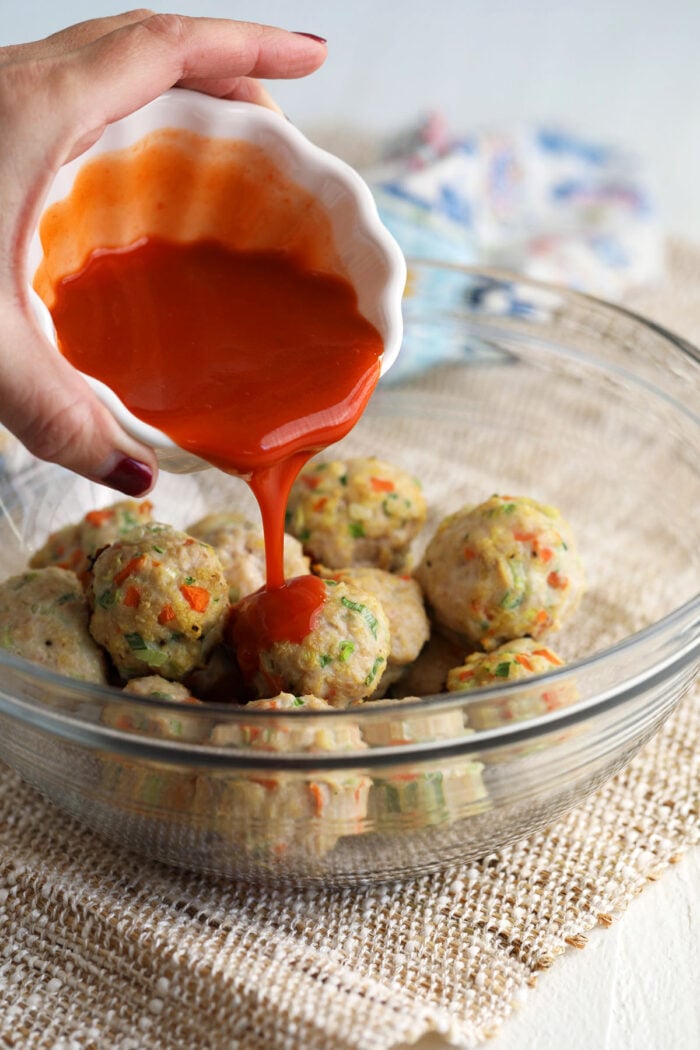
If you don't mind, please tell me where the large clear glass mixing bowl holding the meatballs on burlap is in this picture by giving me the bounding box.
[0,261,700,883]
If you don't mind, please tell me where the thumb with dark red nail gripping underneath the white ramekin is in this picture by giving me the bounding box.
[0,308,157,496]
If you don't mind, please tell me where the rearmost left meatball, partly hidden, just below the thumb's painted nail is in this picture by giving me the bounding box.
[29,500,153,579]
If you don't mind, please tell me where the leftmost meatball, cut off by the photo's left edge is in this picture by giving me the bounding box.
[0,566,107,684]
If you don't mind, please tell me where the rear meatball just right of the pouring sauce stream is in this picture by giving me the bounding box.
[287,457,426,571]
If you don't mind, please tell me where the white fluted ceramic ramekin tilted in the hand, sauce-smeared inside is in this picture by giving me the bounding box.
[28,88,406,473]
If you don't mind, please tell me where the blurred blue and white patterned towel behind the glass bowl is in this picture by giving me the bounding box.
[365,114,663,381]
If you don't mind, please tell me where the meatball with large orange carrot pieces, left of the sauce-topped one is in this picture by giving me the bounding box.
[90,523,229,681]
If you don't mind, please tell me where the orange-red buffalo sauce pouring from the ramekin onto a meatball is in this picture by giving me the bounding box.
[44,131,383,663]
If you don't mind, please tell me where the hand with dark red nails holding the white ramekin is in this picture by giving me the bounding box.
[0,11,325,496]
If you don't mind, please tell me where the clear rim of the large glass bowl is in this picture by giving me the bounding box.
[0,264,700,769]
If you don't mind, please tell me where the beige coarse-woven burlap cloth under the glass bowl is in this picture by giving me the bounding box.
[0,245,700,1050]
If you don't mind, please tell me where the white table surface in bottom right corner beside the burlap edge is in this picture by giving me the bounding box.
[395,847,700,1050]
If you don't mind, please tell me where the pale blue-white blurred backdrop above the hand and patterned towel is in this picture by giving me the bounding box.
[0,0,700,242]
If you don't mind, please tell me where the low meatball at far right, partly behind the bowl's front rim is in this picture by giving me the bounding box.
[447,638,578,730]
